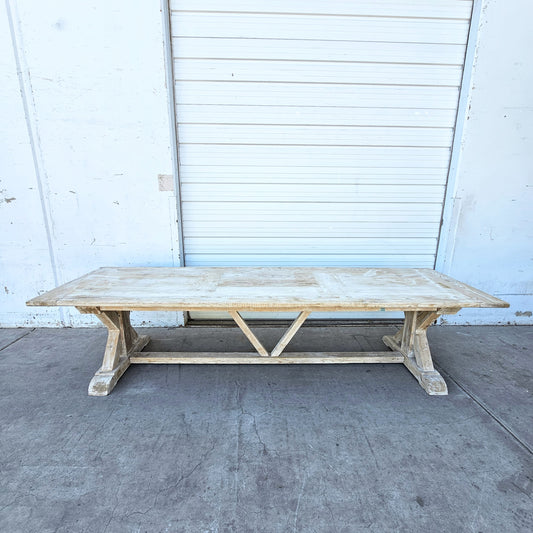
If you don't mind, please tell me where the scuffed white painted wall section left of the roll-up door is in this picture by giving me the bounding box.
[0,0,182,326]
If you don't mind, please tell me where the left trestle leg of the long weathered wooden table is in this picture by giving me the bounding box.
[80,309,150,396]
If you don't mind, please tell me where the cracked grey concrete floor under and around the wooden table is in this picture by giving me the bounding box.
[0,326,533,533]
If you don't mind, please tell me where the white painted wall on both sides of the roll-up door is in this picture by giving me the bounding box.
[0,0,533,327]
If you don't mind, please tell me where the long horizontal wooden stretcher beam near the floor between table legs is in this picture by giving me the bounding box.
[130,351,404,365]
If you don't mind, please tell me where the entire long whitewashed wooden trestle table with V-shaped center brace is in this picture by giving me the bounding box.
[28,267,509,396]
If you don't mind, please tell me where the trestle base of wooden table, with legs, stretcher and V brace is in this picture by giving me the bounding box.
[78,307,456,396]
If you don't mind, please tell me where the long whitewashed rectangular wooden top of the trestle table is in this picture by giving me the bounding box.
[27,267,509,311]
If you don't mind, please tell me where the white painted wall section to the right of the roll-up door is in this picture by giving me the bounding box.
[434,0,533,324]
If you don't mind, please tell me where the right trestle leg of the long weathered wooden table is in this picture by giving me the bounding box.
[383,311,448,396]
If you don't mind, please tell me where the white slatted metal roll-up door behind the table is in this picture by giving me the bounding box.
[170,0,472,320]
